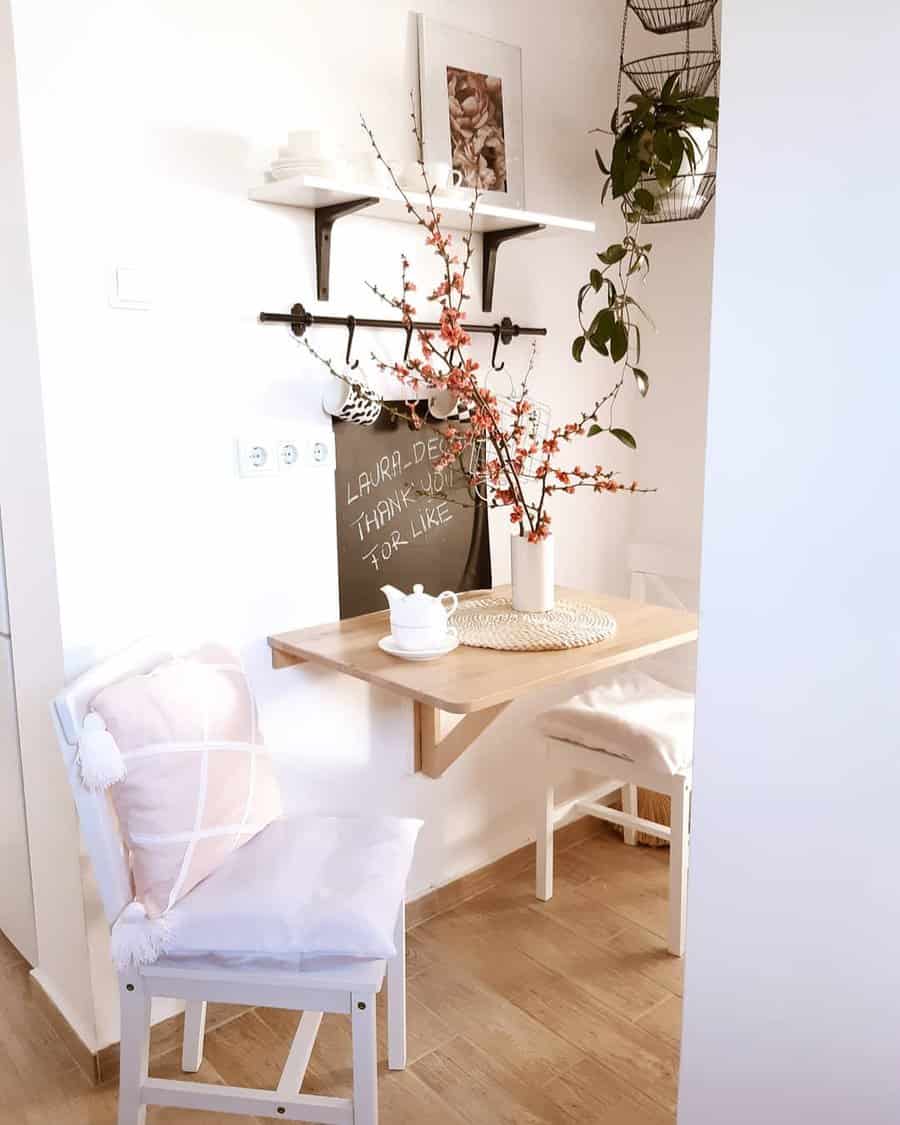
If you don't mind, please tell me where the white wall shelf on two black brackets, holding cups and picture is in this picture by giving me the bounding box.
[250,176,596,312]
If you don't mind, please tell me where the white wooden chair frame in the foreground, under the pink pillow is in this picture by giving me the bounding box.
[54,644,406,1125]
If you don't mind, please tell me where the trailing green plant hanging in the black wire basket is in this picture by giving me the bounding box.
[572,74,719,436]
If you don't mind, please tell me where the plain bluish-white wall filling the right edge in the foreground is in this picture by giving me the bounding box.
[678,0,900,1125]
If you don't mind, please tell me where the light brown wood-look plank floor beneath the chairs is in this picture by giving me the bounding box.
[0,826,682,1125]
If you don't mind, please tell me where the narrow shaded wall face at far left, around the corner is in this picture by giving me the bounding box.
[0,0,95,1041]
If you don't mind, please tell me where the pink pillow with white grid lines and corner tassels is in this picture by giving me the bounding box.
[91,645,281,917]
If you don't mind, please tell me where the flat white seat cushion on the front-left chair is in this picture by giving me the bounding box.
[167,817,422,968]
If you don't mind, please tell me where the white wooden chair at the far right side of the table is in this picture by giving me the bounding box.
[536,545,698,957]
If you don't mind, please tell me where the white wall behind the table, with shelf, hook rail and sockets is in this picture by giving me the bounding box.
[7,0,661,1042]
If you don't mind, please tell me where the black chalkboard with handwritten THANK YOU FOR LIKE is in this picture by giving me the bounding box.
[334,403,491,618]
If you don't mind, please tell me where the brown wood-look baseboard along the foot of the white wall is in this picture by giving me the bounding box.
[32,817,604,1083]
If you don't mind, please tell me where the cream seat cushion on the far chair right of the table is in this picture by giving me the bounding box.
[538,671,694,775]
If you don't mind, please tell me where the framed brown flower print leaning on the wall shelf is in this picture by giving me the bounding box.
[417,12,525,208]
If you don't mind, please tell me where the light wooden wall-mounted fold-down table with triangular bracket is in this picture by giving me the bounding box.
[269,587,698,777]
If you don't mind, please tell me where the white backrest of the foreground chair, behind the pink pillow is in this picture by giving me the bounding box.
[53,640,173,925]
